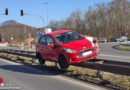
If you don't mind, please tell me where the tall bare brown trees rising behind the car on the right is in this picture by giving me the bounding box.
[50,0,130,39]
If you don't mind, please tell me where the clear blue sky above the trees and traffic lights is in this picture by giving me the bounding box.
[0,0,113,28]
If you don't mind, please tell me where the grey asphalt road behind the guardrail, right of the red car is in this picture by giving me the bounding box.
[97,43,130,62]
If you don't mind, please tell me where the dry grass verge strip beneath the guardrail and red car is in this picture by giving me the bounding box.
[0,53,130,90]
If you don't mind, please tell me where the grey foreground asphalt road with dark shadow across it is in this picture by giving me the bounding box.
[0,58,103,90]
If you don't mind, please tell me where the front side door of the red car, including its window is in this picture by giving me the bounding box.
[46,36,59,61]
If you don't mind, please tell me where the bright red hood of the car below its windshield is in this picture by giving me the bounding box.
[61,38,92,50]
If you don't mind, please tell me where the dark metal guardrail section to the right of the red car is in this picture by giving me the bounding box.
[74,61,130,76]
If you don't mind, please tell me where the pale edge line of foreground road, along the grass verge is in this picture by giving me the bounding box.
[0,58,107,90]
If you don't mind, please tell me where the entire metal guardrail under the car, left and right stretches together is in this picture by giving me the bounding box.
[0,49,130,76]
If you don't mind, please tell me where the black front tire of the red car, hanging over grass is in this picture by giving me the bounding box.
[58,55,69,70]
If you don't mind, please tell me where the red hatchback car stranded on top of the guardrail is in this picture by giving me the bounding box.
[36,30,98,69]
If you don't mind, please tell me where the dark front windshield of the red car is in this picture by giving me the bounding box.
[54,32,84,44]
